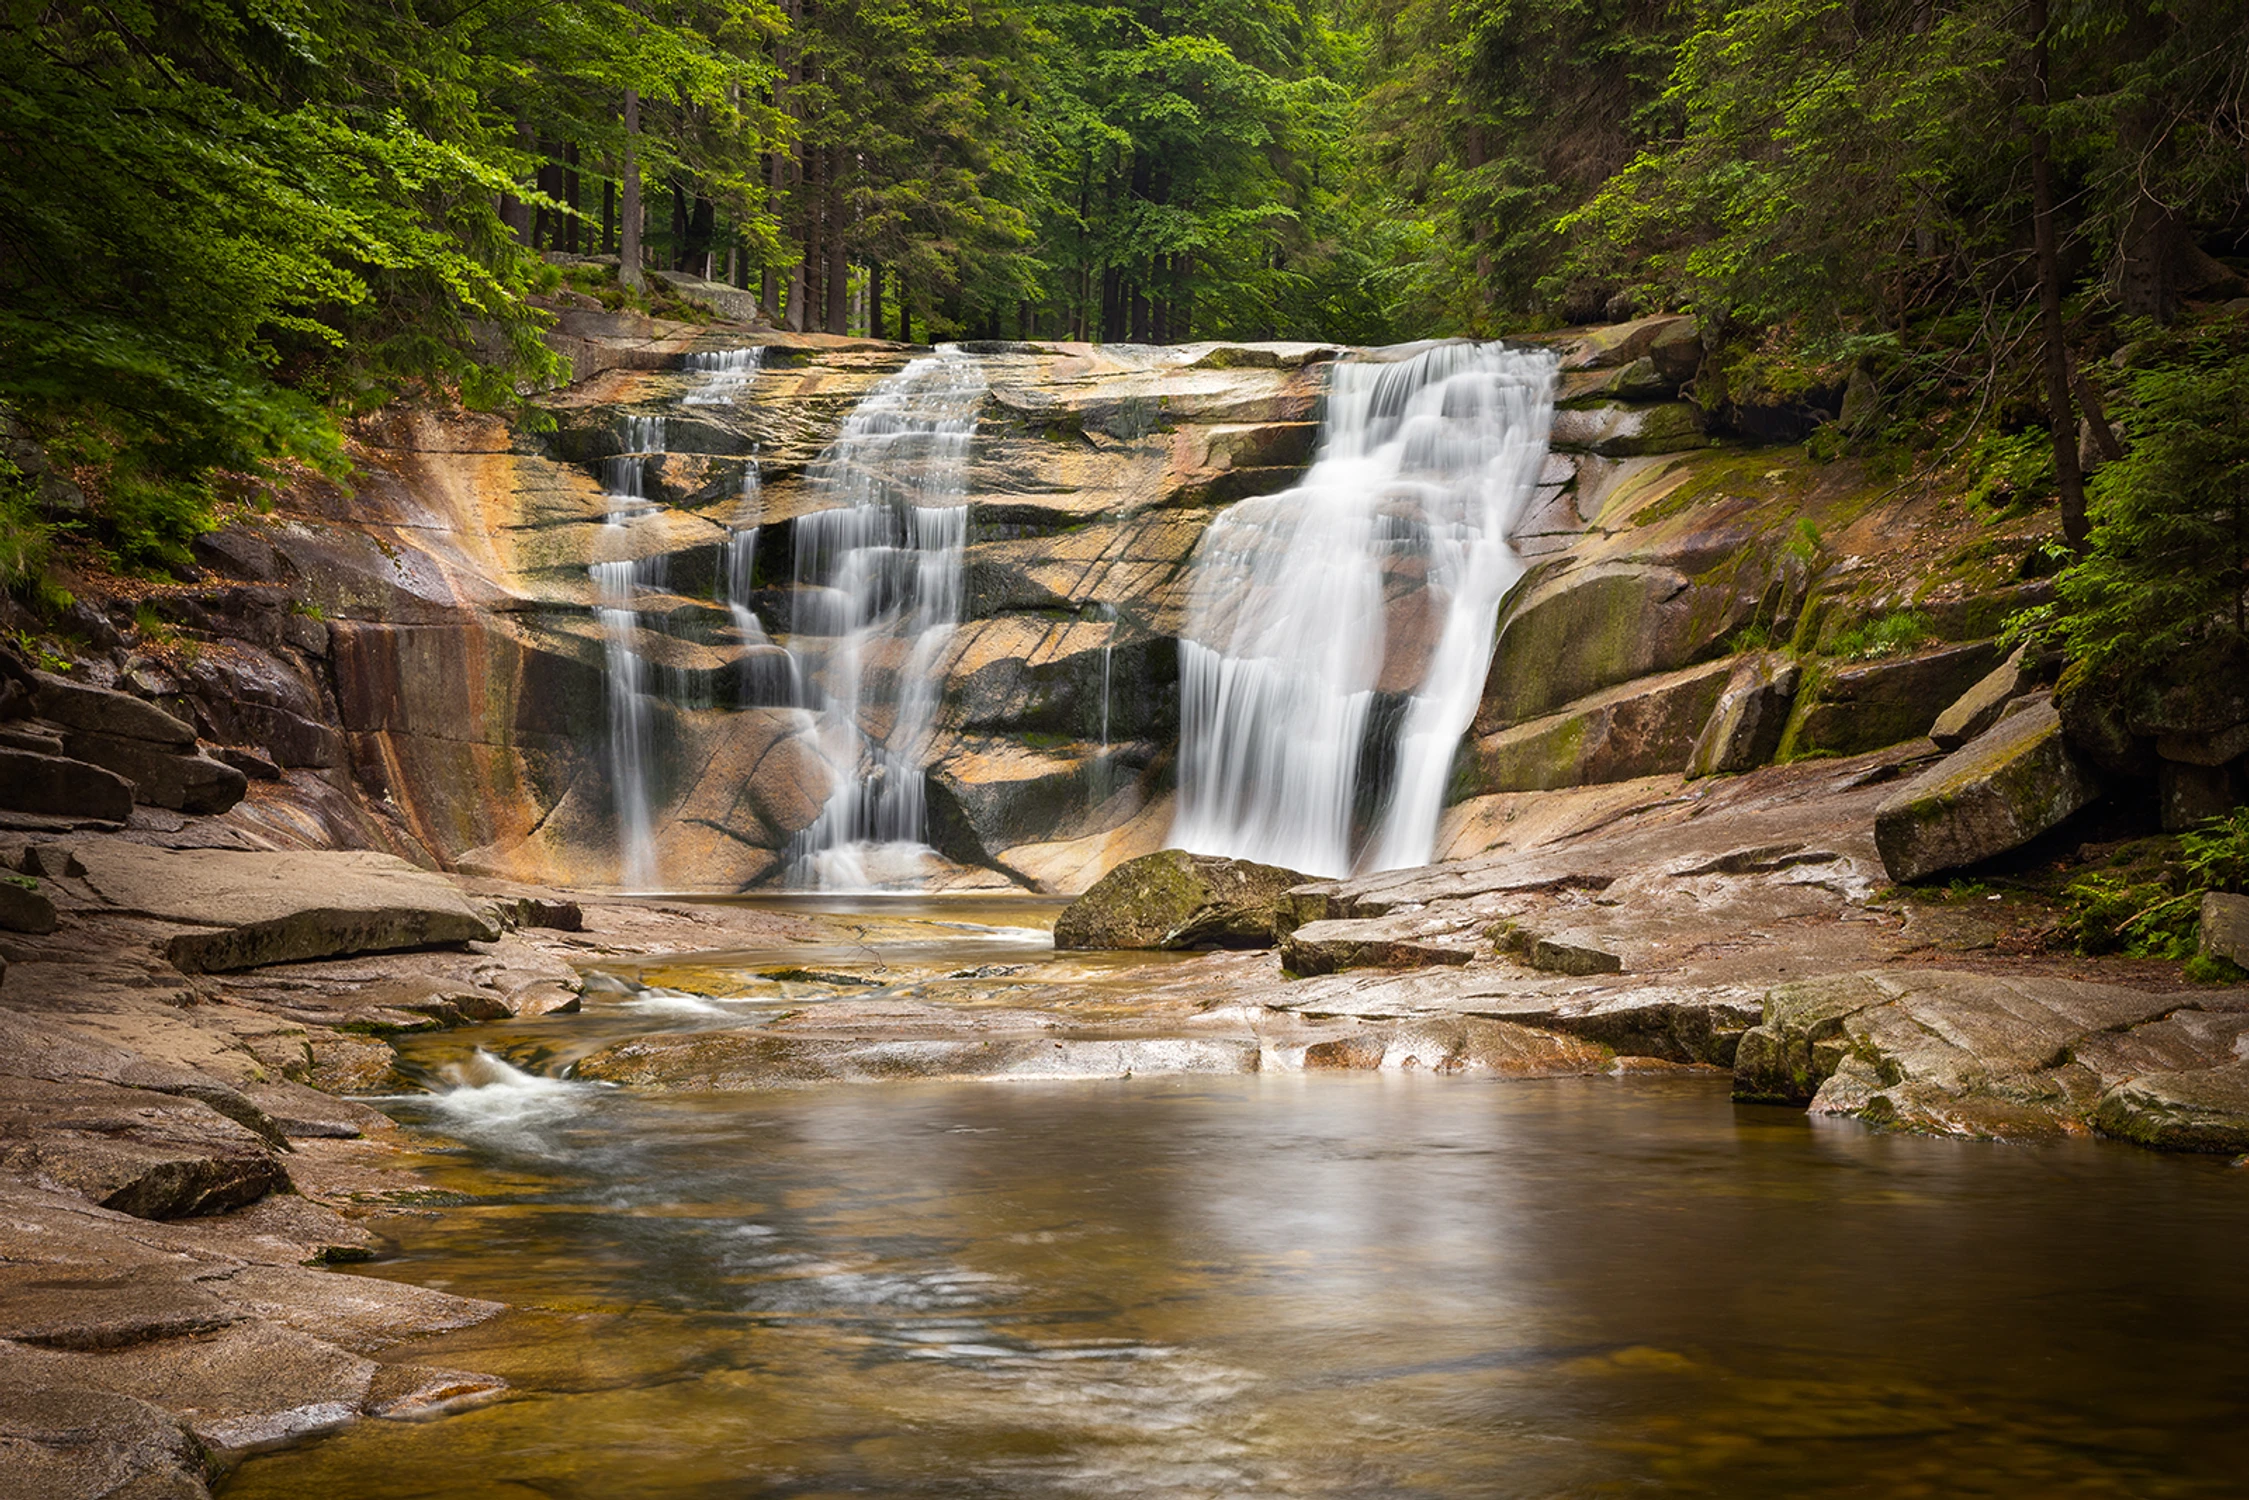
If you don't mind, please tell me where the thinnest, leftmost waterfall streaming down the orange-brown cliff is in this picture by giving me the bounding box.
[589,416,663,891]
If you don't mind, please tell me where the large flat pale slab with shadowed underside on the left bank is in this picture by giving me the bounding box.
[76,839,499,972]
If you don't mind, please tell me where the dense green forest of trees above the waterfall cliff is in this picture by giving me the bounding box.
[0,0,2249,706]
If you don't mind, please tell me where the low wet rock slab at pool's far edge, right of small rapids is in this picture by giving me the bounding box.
[571,1030,1257,1093]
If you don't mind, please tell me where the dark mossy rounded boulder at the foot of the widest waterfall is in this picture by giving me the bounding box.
[1055,850,1309,949]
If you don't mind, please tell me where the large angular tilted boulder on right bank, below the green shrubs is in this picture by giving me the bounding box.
[1873,702,2101,882]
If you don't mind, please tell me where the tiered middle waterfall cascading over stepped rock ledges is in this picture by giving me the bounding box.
[787,346,985,888]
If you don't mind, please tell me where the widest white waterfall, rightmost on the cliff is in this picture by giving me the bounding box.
[1172,344,1554,875]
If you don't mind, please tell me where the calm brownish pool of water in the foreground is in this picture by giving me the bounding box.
[225,1068,2249,1500]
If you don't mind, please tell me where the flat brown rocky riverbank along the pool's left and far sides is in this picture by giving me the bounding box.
[0,747,2249,1496]
